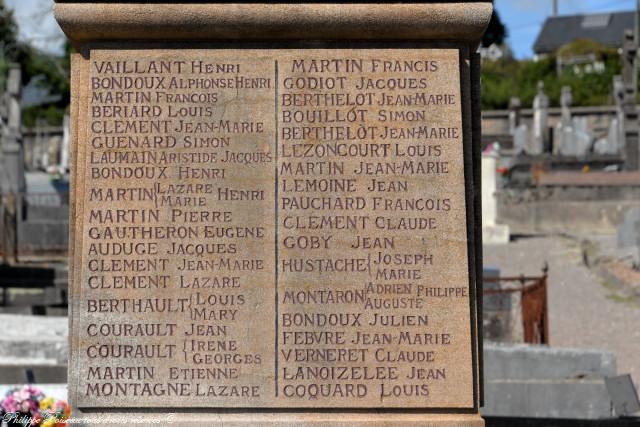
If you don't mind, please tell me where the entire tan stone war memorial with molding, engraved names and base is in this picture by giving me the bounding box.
[54,1,492,427]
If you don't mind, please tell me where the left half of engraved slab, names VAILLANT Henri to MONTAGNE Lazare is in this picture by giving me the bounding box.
[78,51,275,407]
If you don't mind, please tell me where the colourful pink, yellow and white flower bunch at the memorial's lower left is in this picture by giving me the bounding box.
[0,385,71,427]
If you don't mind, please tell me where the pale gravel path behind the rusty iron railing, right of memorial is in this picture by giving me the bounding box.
[484,236,640,384]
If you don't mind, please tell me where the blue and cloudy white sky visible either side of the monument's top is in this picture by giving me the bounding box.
[5,0,636,59]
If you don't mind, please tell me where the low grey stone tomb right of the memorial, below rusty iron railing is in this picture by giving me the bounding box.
[482,344,616,419]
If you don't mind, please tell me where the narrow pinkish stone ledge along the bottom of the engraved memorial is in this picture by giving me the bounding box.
[73,412,484,427]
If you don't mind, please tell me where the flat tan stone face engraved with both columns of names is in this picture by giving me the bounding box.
[75,50,474,408]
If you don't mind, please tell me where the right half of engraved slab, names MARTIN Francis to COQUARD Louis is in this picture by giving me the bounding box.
[276,50,473,407]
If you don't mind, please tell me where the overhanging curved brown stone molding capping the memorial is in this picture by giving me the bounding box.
[54,0,493,46]
